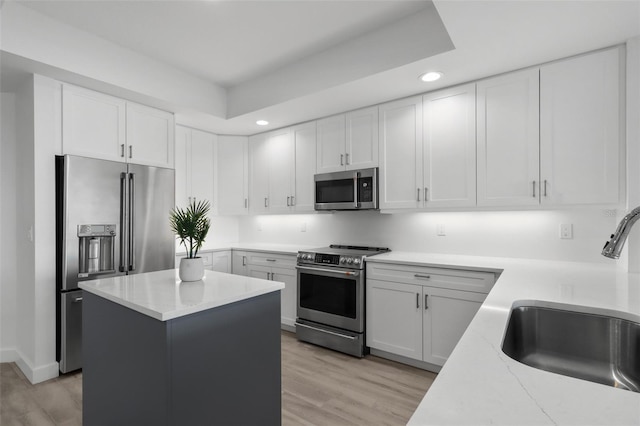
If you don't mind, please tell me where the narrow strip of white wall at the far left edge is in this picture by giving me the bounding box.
[0,93,17,362]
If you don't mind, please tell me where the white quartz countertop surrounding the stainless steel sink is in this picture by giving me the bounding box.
[367,252,640,426]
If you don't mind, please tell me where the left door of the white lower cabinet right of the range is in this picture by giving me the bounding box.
[366,279,422,360]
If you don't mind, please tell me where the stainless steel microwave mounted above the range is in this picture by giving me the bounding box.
[314,167,378,210]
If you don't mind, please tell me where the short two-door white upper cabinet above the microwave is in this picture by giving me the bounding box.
[317,106,378,173]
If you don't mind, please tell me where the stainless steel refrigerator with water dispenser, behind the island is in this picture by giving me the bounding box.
[56,155,175,373]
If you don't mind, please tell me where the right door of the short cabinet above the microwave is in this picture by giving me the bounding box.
[345,106,378,170]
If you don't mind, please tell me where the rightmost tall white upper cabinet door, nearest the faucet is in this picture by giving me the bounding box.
[540,48,622,205]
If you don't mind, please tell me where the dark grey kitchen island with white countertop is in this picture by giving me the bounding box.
[80,270,284,425]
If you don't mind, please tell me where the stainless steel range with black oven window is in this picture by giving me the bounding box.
[296,245,389,357]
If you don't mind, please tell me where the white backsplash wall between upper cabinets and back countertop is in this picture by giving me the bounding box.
[240,209,617,263]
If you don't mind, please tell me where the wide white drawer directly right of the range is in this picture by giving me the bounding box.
[367,263,495,293]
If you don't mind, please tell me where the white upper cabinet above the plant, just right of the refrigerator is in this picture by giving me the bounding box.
[175,126,216,209]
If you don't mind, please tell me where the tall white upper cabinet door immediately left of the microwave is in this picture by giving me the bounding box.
[291,122,316,212]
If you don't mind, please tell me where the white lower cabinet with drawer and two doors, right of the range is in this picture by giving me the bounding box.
[366,264,495,366]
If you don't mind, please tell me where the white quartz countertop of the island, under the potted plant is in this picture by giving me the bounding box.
[79,269,284,321]
